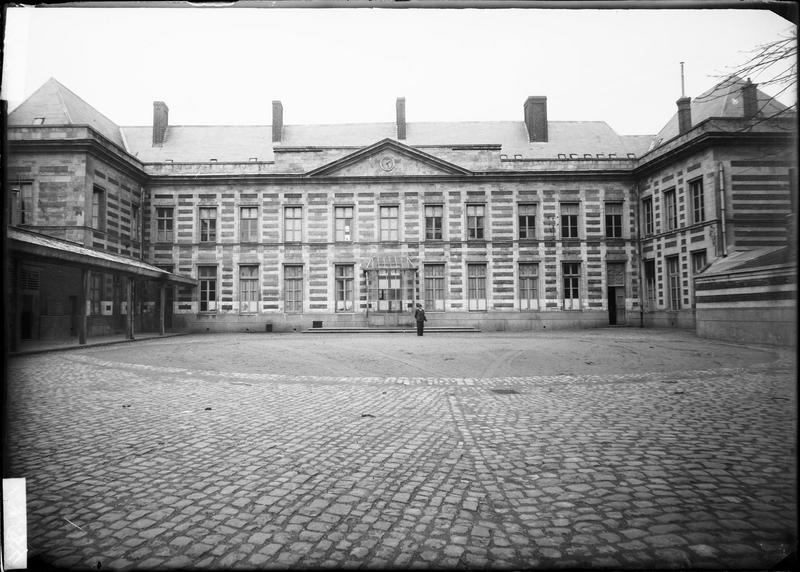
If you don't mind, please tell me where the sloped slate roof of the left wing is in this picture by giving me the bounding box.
[8,78,125,148]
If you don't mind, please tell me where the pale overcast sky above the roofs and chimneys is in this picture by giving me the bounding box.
[2,8,796,134]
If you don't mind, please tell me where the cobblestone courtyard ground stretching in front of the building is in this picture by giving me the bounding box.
[6,329,797,569]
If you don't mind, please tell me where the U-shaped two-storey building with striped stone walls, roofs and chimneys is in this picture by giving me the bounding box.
[7,78,796,344]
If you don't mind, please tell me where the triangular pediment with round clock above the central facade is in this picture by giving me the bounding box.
[306,139,471,177]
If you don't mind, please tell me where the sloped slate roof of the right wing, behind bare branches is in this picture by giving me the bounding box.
[653,75,788,147]
